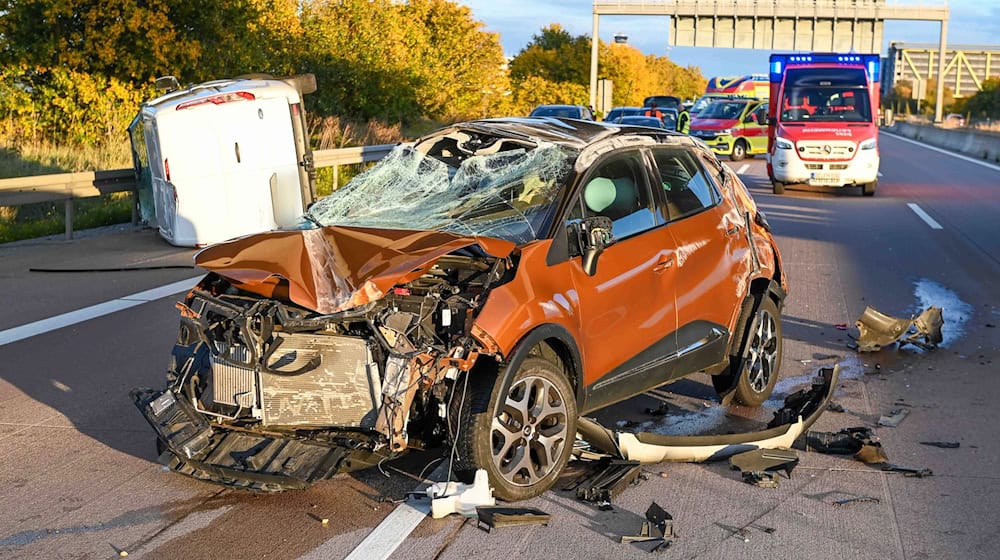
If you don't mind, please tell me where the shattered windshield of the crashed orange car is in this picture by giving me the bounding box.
[306,134,573,244]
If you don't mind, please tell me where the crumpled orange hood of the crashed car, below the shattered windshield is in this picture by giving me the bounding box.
[195,226,514,314]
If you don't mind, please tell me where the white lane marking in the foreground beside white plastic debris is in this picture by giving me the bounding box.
[299,461,448,560]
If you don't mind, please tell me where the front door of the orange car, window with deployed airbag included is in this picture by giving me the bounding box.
[567,149,677,410]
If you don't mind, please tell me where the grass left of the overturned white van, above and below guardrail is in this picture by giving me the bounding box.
[0,139,132,243]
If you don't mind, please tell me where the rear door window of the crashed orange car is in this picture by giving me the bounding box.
[653,148,720,221]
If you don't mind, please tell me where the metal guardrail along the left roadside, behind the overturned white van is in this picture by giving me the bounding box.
[0,144,395,239]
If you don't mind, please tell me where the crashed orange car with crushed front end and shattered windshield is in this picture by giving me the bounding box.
[132,118,786,500]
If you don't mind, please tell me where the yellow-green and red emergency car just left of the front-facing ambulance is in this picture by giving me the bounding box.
[690,97,767,161]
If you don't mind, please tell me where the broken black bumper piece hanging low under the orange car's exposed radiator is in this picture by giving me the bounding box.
[131,389,384,492]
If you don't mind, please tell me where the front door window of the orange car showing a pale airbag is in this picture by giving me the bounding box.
[569,153,658,239]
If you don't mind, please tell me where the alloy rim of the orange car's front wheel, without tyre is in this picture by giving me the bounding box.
[490,376,569,486]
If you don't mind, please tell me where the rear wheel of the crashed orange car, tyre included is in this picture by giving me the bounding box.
[734,295,782,406]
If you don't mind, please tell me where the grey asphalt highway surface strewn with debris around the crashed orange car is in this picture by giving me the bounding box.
[0,133,1000,560]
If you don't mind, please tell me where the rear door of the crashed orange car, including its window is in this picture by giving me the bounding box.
[652,146,748,377]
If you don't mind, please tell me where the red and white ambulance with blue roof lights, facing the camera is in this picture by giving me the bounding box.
[767,53,879,196]
